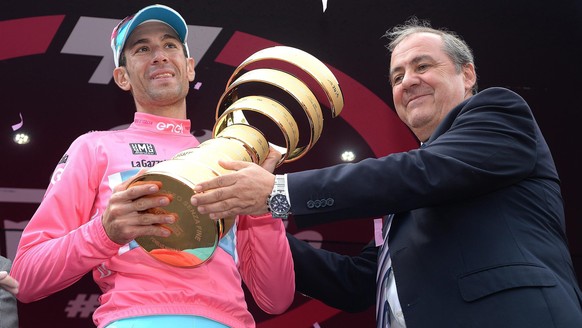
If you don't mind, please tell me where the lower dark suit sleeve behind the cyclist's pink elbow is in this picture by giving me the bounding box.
[287,233,378,312]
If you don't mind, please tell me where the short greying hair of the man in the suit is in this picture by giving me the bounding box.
[384,16,478,94]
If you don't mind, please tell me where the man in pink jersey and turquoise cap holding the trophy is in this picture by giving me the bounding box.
[11,5,295,328]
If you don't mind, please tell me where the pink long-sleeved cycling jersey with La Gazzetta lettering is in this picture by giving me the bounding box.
[11,113,295,328]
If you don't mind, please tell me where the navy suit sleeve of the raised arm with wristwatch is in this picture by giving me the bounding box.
[287,88,544,228]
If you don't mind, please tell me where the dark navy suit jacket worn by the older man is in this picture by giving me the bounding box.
[288,88,582,328]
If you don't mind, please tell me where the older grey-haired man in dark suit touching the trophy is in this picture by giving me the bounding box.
[193,19,582,328]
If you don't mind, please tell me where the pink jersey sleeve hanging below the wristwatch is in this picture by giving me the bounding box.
[237,215,295,314]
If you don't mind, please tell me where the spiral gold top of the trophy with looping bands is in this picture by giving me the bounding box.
[213,46,344,165]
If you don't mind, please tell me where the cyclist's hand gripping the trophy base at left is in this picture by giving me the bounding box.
[101,177,177,245]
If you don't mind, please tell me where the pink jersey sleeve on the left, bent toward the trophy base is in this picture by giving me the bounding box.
[11,134,120,302]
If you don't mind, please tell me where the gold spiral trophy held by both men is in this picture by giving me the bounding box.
[130,46,344,268]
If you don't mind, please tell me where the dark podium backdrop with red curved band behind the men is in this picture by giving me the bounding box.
[0,0,582,328]
